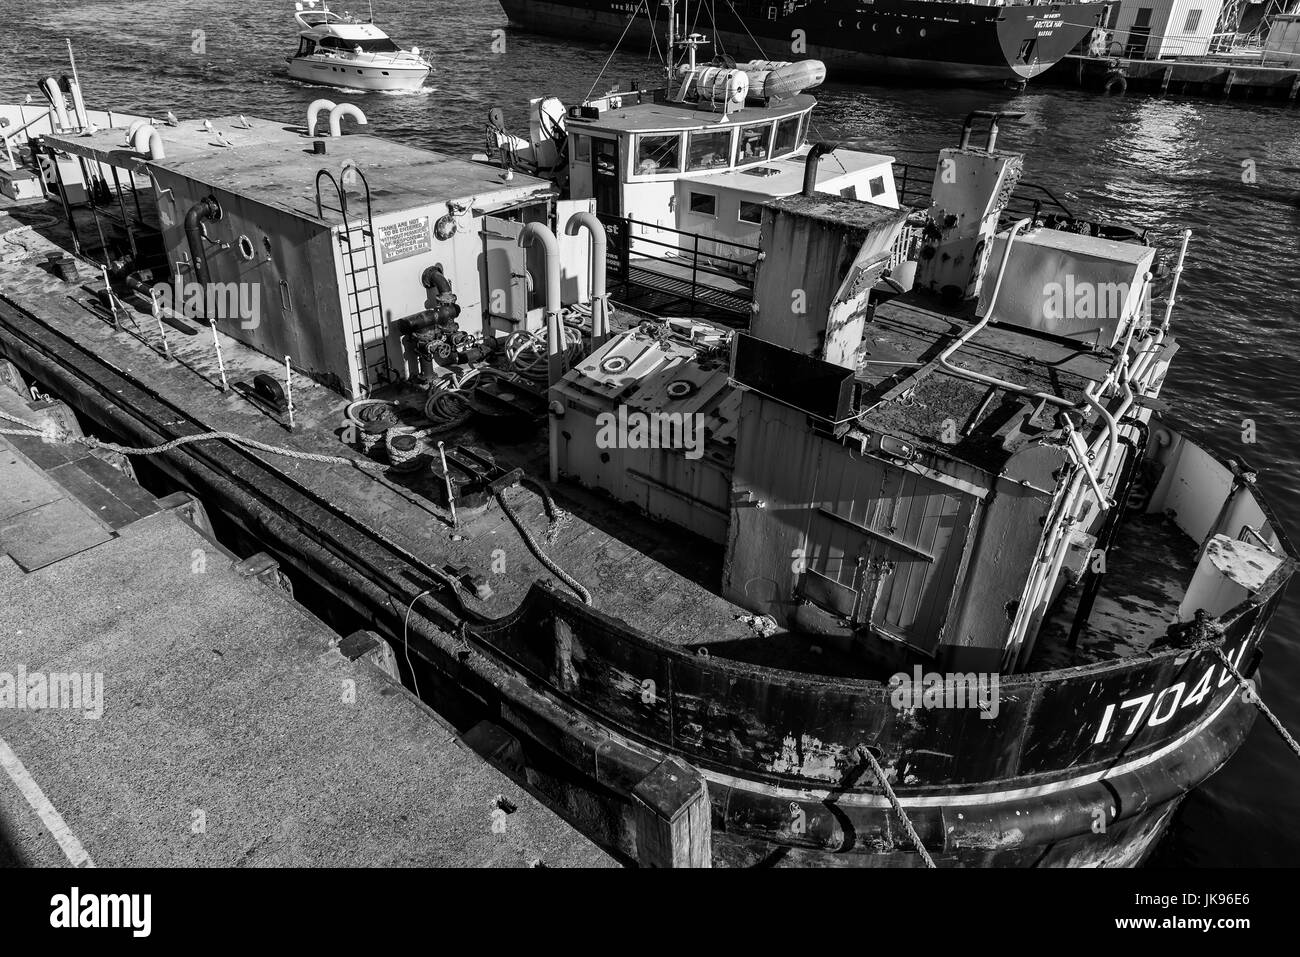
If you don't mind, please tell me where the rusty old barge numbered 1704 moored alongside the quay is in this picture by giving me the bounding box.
[0,78,1295,866]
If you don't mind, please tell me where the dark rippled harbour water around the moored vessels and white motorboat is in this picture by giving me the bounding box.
[0,0,1300,866]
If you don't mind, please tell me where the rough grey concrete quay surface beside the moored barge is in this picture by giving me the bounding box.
[0,389,614,867]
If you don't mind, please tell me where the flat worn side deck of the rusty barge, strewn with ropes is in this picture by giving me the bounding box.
[0,197,754,655]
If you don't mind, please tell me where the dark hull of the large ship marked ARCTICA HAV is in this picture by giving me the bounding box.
[502,0,1104,82]
